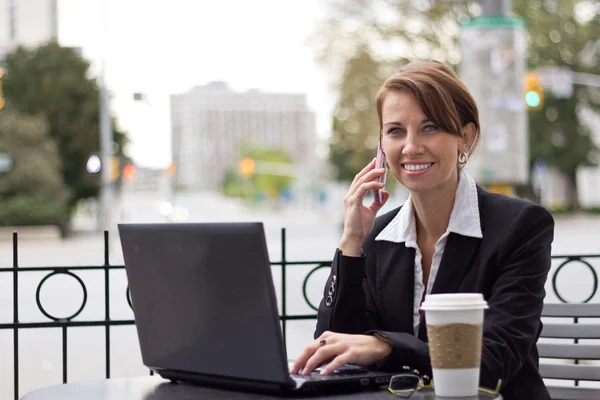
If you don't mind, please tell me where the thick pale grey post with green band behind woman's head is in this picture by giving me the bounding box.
[459,0,529,193]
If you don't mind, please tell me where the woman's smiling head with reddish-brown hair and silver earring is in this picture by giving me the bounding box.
[376,62,479,199]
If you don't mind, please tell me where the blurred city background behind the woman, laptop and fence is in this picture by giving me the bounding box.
[0,0,600,399]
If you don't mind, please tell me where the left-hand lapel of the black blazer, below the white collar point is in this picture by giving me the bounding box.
[377,241,415,334]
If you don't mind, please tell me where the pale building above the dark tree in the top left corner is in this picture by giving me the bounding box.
[0,0,58,58]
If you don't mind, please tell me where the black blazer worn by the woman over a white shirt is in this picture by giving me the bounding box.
[315,187,554,400]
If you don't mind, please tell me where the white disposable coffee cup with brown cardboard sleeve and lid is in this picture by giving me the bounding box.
[421,293,488,397]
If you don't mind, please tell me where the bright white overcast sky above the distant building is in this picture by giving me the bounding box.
[59,0,333,167]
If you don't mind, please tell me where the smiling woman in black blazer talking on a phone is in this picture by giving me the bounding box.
[291,61,554,399]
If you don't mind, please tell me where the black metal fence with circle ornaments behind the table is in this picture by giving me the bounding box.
[0,228,600,400]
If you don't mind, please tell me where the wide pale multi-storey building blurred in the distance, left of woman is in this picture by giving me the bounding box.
[171,82,316,190]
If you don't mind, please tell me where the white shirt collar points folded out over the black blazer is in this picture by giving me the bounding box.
[375,170,483,247]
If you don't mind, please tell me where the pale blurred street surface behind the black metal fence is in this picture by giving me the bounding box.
[0,194,600,399]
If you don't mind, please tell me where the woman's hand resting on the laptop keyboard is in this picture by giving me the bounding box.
[290,331,392,375]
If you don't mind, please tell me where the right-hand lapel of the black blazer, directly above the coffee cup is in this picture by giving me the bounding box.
[431,232,481,293]
